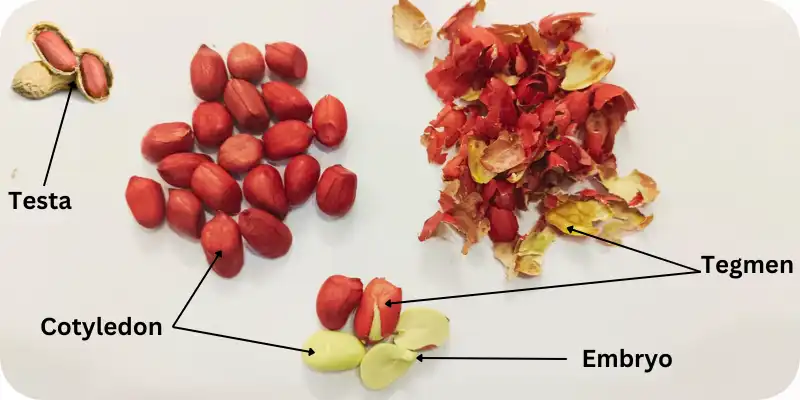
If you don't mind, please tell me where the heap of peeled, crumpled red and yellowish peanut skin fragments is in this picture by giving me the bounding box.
[393,0,659,277]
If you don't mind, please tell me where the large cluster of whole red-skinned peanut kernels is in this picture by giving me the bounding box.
[125,42,357,278]
